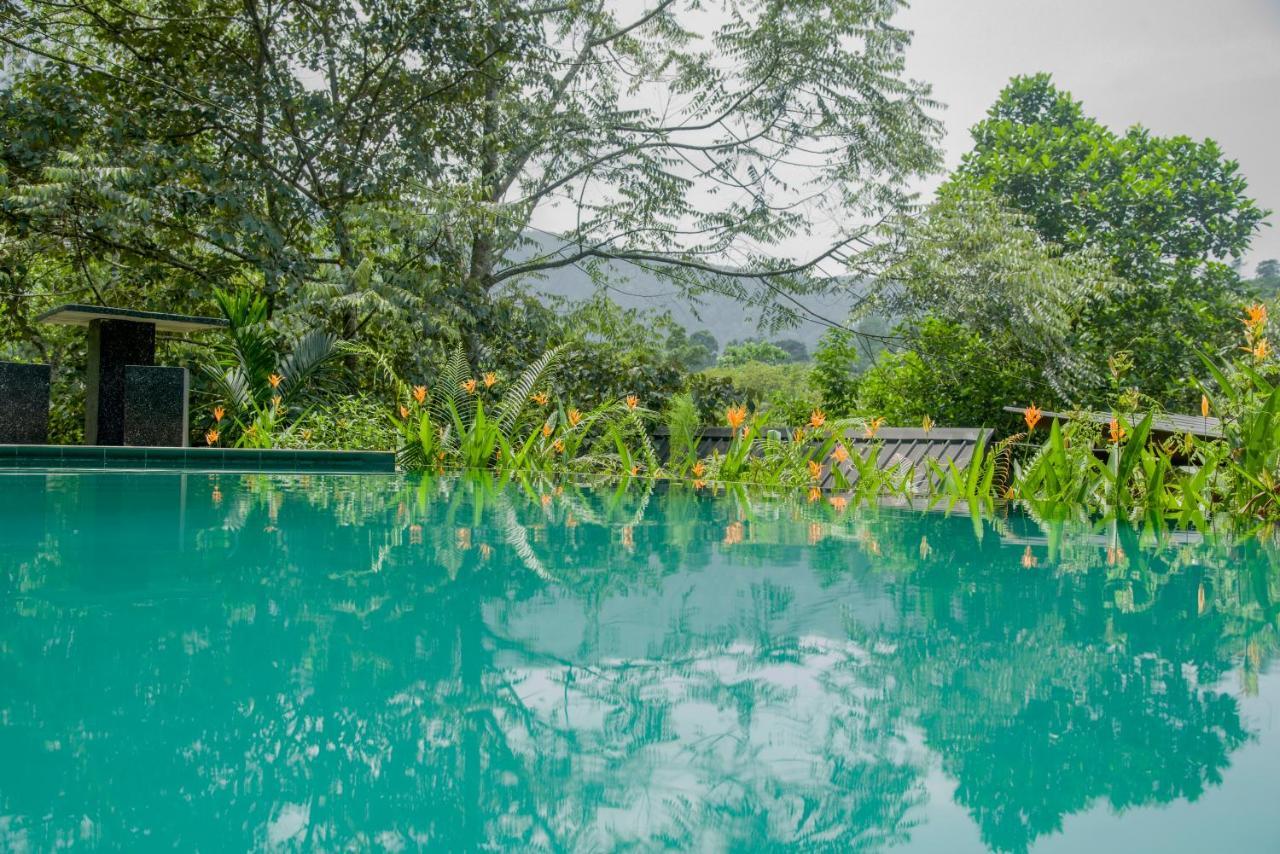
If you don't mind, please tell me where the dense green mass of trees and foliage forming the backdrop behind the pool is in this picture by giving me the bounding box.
[0,0,1280,447]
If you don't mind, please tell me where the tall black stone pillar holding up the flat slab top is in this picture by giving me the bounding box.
[84,320,156,444]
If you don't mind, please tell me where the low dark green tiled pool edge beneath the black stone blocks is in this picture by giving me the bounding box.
[0,444,396,474]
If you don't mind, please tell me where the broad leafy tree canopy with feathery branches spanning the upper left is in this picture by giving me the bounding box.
[0,0,938,363]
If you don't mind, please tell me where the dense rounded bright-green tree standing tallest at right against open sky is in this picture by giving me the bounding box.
[940,74,1268,408]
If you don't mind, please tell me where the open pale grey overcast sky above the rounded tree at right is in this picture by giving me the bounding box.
[901,0,1280,274]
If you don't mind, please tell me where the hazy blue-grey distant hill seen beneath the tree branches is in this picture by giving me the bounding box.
[499,234,854,352]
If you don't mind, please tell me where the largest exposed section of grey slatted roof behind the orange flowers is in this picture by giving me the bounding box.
[820,428,991,492]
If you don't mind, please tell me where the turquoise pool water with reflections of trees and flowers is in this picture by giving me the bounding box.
[0,472,1280,854]
